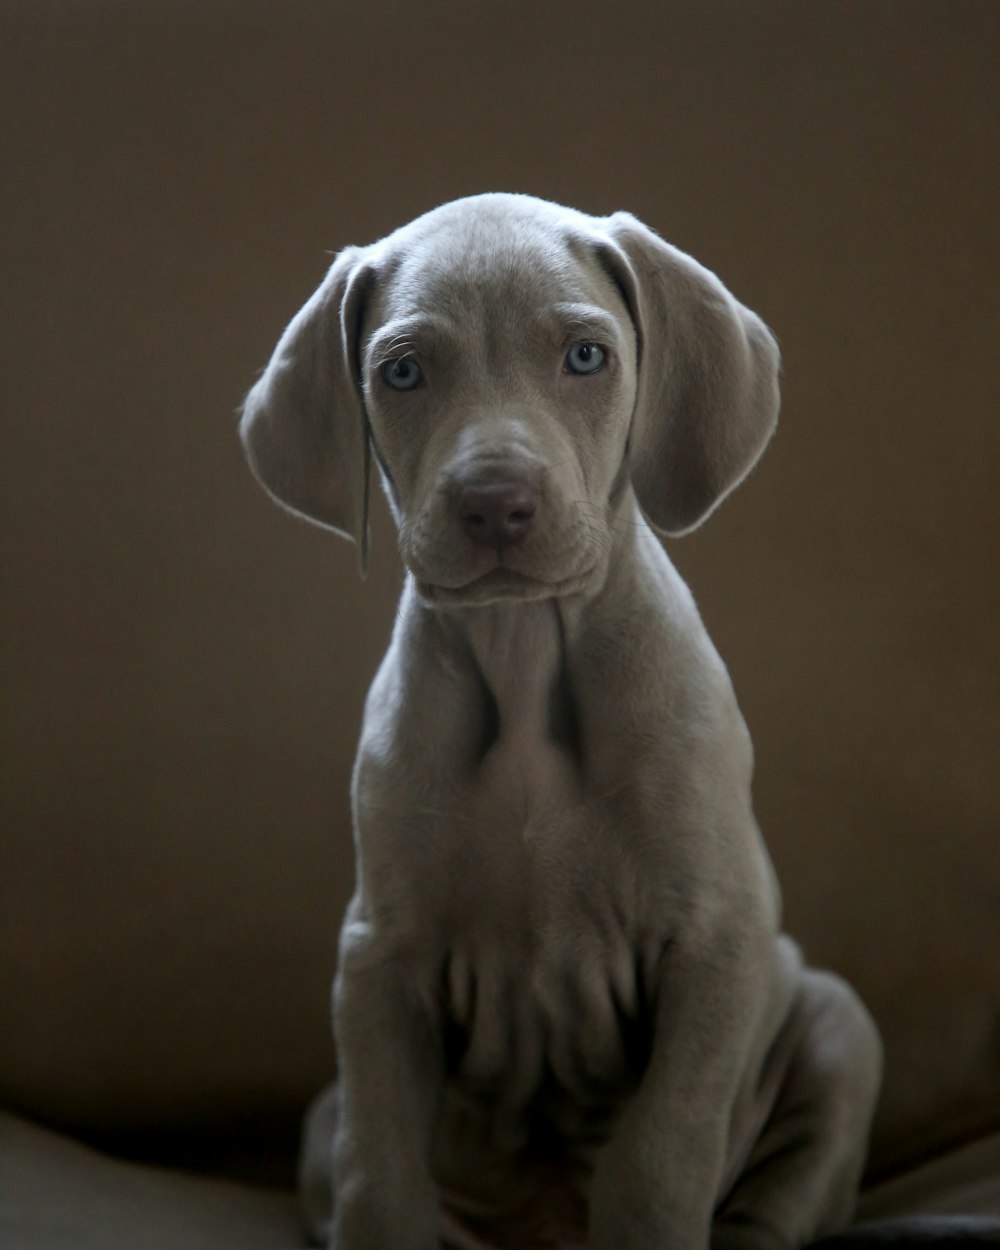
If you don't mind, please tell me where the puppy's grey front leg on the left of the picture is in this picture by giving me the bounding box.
[330,919,444,1250]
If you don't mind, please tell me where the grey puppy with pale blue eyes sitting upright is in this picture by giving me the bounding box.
[241,195,881,1250]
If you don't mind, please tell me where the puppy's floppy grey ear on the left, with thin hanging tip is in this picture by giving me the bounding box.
[240,248,373,573]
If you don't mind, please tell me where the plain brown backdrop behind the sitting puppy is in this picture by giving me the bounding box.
[0,0,1000,1161]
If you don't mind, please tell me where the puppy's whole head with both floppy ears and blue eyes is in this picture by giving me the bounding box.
[241,195,778,605]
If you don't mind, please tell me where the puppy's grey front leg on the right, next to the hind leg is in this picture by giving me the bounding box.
[588,924,774,1250]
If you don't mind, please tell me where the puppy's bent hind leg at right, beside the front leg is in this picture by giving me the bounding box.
[711,970,881,1250]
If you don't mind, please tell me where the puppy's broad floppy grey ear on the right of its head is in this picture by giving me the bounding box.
[605,213,780,534]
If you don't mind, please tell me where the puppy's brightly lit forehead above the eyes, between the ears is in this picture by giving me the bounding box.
[374,195,613,320]
